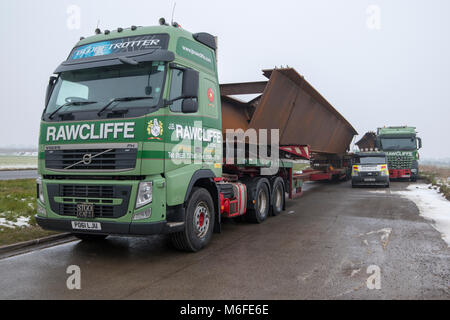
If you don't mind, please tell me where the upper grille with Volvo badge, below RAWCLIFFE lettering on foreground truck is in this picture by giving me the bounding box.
[45,148,137,170]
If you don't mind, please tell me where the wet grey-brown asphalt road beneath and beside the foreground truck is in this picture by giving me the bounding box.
[0,182,450,299]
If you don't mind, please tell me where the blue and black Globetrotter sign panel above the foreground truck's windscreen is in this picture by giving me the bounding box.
[69,34,169,60]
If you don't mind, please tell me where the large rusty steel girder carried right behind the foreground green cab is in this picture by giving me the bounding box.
[221,68,357,154]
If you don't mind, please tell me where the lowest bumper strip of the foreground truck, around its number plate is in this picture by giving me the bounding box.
[35,215,183,236]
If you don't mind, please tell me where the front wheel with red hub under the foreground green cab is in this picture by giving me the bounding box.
[171,187,214,252]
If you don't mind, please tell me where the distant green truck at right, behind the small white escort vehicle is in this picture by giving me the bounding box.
[376,126,422,181]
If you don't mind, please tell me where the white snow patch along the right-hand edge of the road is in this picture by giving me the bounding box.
[392,184,450,247]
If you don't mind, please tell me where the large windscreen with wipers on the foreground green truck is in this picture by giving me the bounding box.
[45,62,165,114]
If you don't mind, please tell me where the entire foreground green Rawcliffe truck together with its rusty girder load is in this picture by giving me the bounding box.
[36,20,357,251]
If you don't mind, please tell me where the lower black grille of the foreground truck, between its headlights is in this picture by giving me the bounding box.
[47,184,131,218]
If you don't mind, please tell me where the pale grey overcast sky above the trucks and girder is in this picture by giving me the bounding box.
[0,0,450,158]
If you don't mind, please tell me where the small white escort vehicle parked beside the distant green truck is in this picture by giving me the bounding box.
[352,151,389,187]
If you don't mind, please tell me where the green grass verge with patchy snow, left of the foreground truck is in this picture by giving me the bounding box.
[0,179,57,246]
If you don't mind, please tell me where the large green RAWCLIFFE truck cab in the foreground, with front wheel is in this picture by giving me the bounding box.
[36,21,222,251]
